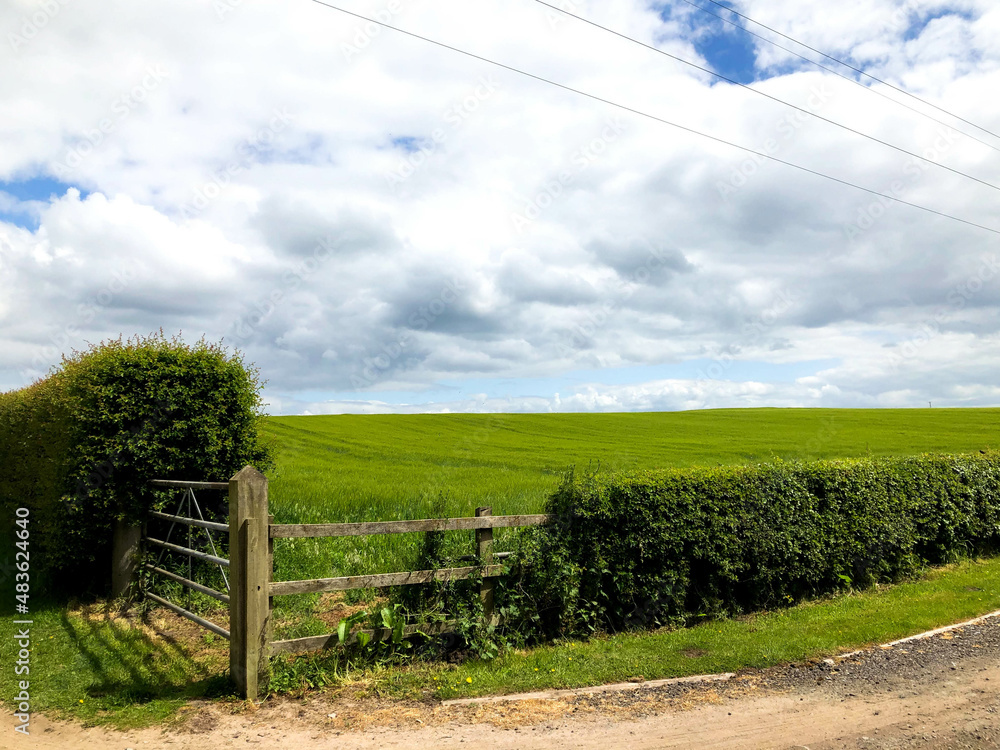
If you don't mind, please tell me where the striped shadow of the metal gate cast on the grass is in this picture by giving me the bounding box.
[61,607,234,707]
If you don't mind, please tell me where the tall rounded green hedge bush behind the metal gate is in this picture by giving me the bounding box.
[0,332,271,593]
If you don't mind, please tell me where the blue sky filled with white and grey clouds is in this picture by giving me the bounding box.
[0,0,1000,414]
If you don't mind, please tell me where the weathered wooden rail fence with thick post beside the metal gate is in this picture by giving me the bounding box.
[145,466,550,698]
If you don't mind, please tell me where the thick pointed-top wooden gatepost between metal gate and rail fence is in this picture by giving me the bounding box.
[229,466,271,699]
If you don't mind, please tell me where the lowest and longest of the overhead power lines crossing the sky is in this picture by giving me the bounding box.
[310,0,1000,235]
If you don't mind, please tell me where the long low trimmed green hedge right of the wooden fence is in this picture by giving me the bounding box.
[532,452,1000,634]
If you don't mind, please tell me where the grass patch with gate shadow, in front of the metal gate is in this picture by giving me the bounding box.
[0,601,234,729]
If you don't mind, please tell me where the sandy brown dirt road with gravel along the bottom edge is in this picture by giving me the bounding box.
[7,618,1000,750]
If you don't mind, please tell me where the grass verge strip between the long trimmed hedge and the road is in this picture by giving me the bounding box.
[373,558,1000,699]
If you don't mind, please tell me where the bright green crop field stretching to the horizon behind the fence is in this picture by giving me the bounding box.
[265,409,1000,580]
